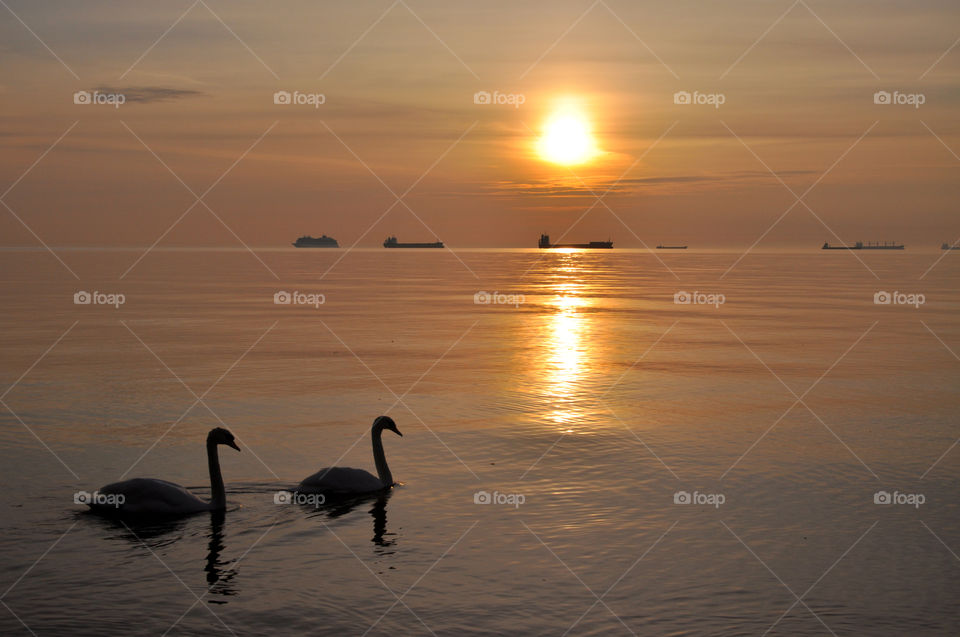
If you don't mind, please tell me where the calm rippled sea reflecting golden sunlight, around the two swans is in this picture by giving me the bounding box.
[0,249,960,635]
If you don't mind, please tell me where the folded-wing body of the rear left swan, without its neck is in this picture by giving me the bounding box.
[90,478,210,515]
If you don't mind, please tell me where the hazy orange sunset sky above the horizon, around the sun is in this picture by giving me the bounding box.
[0,0,960,248]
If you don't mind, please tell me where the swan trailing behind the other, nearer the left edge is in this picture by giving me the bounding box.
[87,427,240,515]
